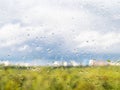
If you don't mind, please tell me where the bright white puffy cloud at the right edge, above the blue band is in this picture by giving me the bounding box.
[74,31,120,53]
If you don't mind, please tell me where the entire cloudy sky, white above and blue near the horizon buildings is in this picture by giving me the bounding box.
[0,0,120,63]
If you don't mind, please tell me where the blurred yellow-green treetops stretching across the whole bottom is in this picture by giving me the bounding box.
[0,66,120,90]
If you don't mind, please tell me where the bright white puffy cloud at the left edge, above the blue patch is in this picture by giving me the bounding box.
[0,24,45,48]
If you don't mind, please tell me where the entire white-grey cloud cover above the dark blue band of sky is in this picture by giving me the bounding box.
[0,0,120,58]
